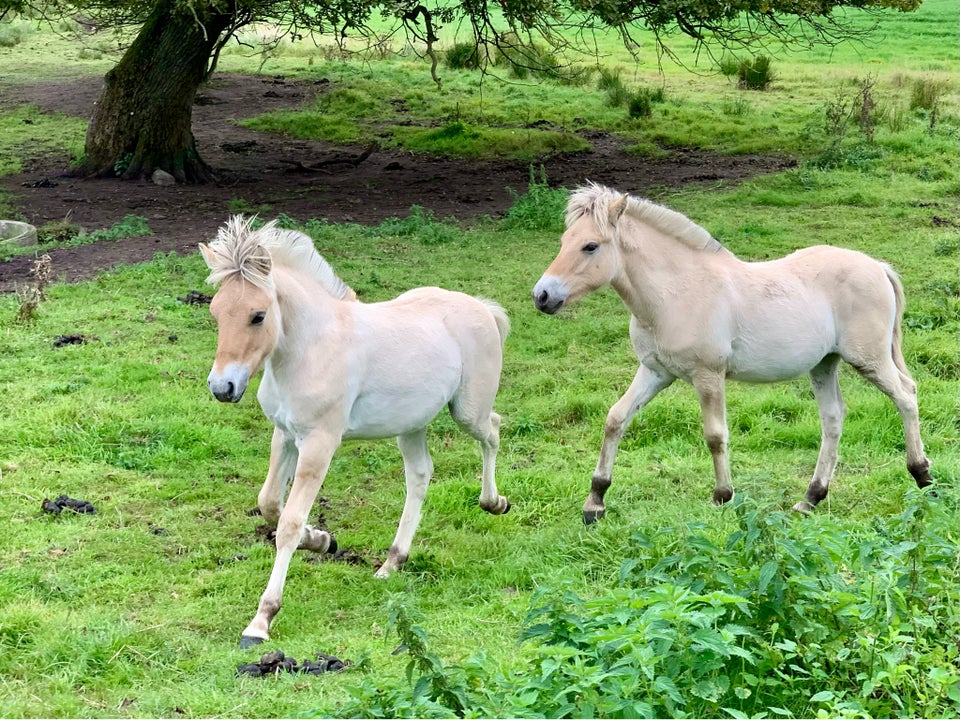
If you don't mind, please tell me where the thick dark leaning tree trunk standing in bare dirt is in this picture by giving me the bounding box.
[79,0,233,183]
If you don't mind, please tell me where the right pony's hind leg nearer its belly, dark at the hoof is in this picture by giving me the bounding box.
[793,355,847,513]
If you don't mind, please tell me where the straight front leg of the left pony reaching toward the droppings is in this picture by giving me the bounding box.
[240,430,340,648]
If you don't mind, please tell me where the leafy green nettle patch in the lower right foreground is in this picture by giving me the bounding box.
[339,490,960,718]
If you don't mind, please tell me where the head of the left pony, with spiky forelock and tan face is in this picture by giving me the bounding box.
[200,215,281,402]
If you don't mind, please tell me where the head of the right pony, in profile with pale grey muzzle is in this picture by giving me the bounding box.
[533,183,628,315]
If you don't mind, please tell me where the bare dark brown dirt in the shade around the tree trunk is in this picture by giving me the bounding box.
[0,75,793,292]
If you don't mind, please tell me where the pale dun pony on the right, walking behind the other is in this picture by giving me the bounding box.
[533,185,932,523]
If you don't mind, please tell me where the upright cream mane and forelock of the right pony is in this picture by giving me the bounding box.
[566,183,726,252]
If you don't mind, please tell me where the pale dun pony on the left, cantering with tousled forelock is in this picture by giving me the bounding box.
[200,216,510,647]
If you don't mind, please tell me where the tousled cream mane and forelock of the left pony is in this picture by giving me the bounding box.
[207,215,356,300]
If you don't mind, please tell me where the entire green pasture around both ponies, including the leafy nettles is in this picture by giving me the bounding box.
[0,0,960,717]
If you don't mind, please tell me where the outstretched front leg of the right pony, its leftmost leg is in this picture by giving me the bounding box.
[583,364,675,525]
